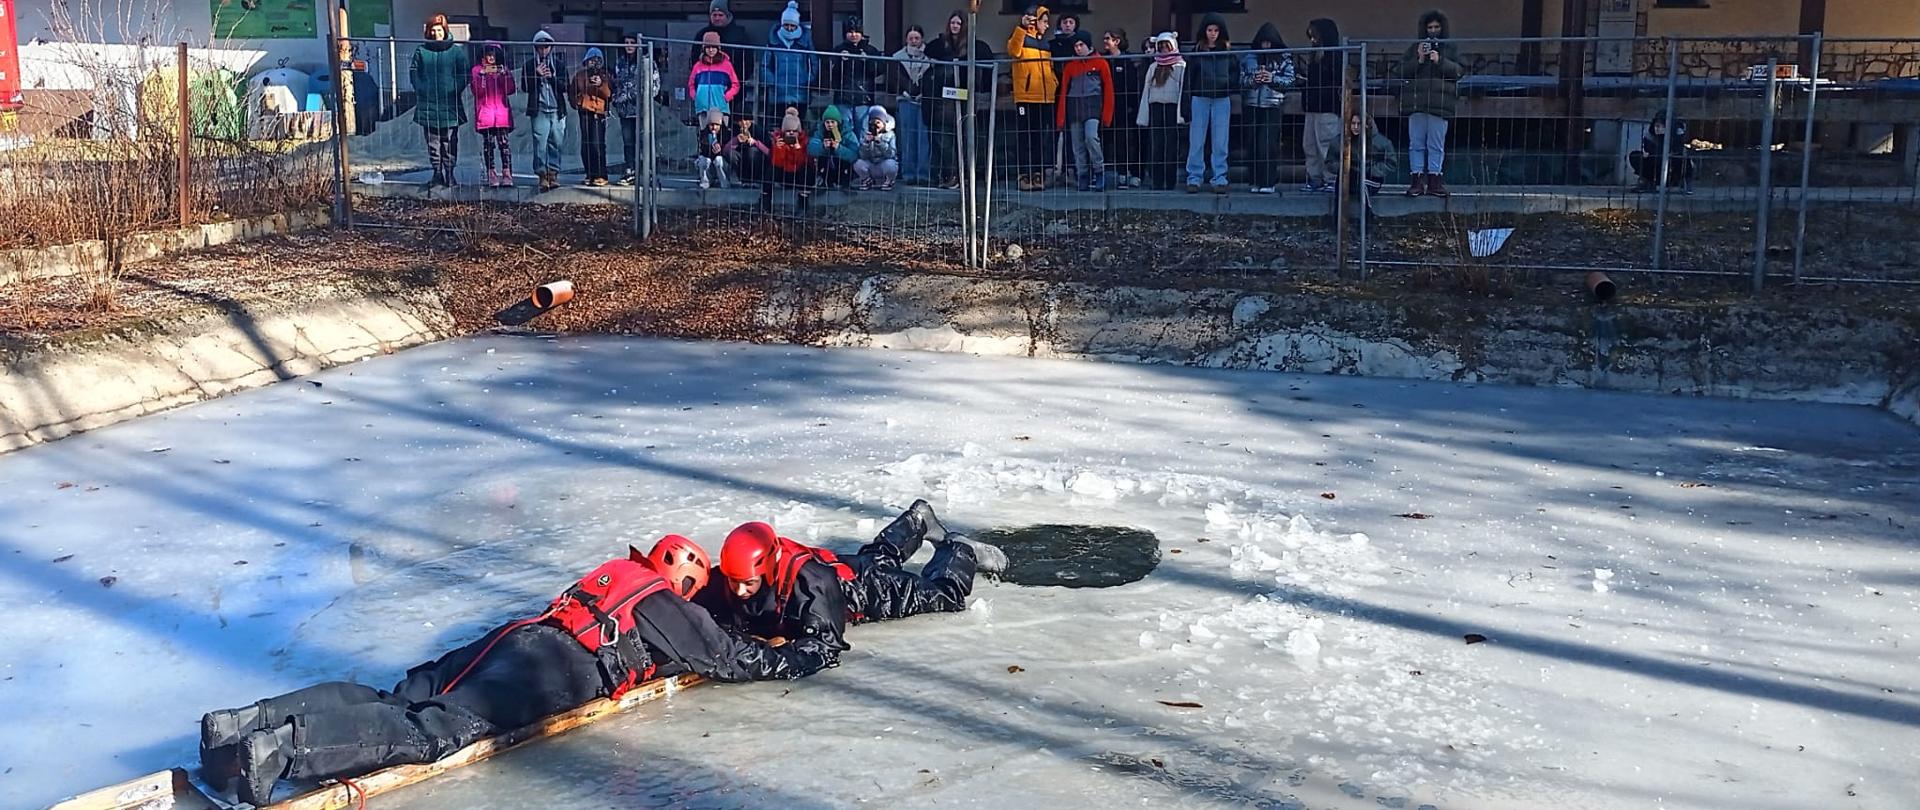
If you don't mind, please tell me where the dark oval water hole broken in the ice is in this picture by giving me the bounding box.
[977,524,1160,587]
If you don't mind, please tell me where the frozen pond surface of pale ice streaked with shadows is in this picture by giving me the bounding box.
[0,338,1920,810]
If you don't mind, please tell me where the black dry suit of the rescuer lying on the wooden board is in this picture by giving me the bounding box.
[200,575,829,798]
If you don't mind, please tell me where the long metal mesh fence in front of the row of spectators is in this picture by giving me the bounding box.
[311,29,1920,282]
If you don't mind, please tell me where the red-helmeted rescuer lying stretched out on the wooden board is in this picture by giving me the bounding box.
[200,536,831,806]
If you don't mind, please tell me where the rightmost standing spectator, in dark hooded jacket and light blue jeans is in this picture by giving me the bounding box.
[1396,12,1467,198]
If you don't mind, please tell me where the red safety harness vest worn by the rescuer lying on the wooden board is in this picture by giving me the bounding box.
[440,553,668,701]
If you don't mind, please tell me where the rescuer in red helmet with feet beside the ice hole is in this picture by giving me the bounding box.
[695,501,1006,662]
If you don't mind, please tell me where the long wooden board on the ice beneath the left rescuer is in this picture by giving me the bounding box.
[48,676,705,810]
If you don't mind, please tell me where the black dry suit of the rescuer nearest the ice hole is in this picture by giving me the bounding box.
[697,511,975,658]
